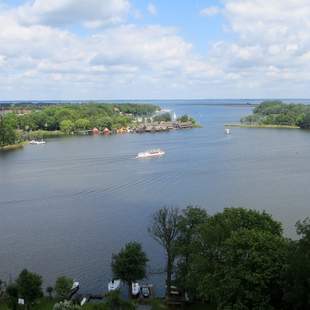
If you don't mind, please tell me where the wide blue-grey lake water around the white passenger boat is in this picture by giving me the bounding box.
[0,101,310,293]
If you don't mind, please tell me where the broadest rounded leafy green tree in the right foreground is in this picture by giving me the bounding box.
[188,208,287,309]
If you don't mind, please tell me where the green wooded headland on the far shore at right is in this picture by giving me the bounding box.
[241,100,310,129]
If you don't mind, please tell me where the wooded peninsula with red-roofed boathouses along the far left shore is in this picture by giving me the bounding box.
[0,103,199,149]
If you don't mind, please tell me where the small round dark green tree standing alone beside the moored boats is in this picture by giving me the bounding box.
[112,242,148,296]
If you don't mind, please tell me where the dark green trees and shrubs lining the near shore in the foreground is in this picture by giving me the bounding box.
[0,206,310,310]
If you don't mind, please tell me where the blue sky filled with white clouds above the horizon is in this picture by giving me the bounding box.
[0,0,310,100]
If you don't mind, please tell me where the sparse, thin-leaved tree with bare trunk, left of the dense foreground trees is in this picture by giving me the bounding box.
[148,207,179,297]
